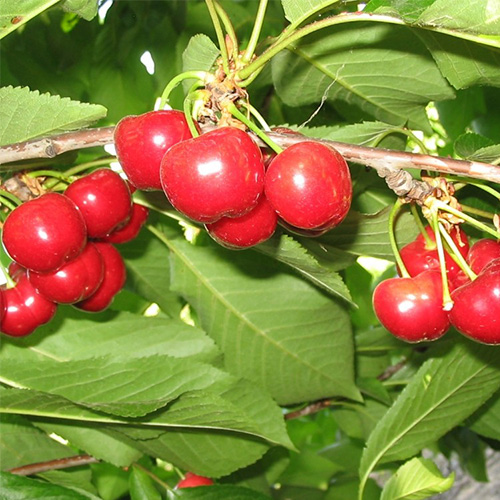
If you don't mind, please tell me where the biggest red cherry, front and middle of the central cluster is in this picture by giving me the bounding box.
[160,127,264,223]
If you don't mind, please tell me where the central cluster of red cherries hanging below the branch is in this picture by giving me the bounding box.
[114,110,352,248]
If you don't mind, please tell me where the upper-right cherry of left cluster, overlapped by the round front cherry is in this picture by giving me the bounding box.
[64,168,132,238]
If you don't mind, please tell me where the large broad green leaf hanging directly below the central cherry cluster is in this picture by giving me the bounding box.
[165,232,359,404]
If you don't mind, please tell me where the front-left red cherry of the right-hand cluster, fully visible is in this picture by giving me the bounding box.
[373,270,450,342]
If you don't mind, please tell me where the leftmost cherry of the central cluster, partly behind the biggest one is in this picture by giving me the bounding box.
[114,110,192,190]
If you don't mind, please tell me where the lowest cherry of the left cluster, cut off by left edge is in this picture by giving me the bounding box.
[0,270,57,337]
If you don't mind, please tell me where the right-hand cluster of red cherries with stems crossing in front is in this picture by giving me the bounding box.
[373,226,500,344]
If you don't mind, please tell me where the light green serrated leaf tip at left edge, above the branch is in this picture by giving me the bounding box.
[0,87,106,146]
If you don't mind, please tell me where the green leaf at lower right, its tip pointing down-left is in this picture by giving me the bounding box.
[360,339,500,498]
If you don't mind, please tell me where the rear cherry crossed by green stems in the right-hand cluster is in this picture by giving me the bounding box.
[400,226,469,288]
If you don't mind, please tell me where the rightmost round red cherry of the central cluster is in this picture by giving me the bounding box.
[265,141,352,229]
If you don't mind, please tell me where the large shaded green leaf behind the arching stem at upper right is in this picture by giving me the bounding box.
[272,23,454,133]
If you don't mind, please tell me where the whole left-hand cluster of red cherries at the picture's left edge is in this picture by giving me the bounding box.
[0,168,148,337]
